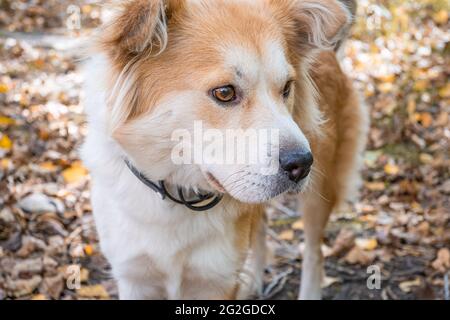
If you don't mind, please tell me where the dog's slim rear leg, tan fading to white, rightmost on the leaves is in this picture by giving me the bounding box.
[299,194,332,300]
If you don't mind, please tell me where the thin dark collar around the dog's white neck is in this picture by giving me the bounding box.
[125,159,223,211]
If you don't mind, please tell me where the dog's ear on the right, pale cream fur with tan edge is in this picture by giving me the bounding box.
[272,0,356,51]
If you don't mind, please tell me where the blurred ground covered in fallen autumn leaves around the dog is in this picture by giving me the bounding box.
[0,0,450,300]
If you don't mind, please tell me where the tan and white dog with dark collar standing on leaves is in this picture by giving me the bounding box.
[82,0,368,299]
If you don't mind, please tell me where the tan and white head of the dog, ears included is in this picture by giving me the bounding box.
[98,0,351,203]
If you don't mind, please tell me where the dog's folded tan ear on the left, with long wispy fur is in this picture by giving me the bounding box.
[100,0,184,57]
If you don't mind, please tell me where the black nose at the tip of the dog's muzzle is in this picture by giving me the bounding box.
[280,149,314,183]
